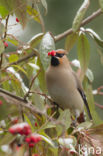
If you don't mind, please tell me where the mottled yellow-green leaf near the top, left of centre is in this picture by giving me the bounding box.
[27,6,40,23]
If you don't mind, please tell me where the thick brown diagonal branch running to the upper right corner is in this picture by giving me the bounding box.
[55,9,102,42]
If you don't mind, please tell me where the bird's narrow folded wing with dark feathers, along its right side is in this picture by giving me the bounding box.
[73,72,92,120]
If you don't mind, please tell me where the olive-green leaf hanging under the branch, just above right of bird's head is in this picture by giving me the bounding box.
[65,33,78,51]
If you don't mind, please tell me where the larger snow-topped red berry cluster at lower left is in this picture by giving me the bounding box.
[9,122,31,135]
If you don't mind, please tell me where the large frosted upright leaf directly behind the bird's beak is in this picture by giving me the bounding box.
[39,32,55,70]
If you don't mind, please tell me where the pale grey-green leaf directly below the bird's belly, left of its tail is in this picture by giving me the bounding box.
[58,109,71,130]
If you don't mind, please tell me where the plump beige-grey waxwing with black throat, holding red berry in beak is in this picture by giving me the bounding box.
[45,49,92,123]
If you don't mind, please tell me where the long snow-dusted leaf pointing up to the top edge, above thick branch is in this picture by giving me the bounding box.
[72,0,90,32]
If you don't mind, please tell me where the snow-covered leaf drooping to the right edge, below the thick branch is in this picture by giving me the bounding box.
[85,28,103,48]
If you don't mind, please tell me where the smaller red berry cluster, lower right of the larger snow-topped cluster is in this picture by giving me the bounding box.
[25,133,41,147]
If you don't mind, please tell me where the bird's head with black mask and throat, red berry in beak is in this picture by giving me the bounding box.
[48,49,67,66]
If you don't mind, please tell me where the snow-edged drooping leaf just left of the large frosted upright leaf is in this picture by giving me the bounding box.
[28,33,43,48]
